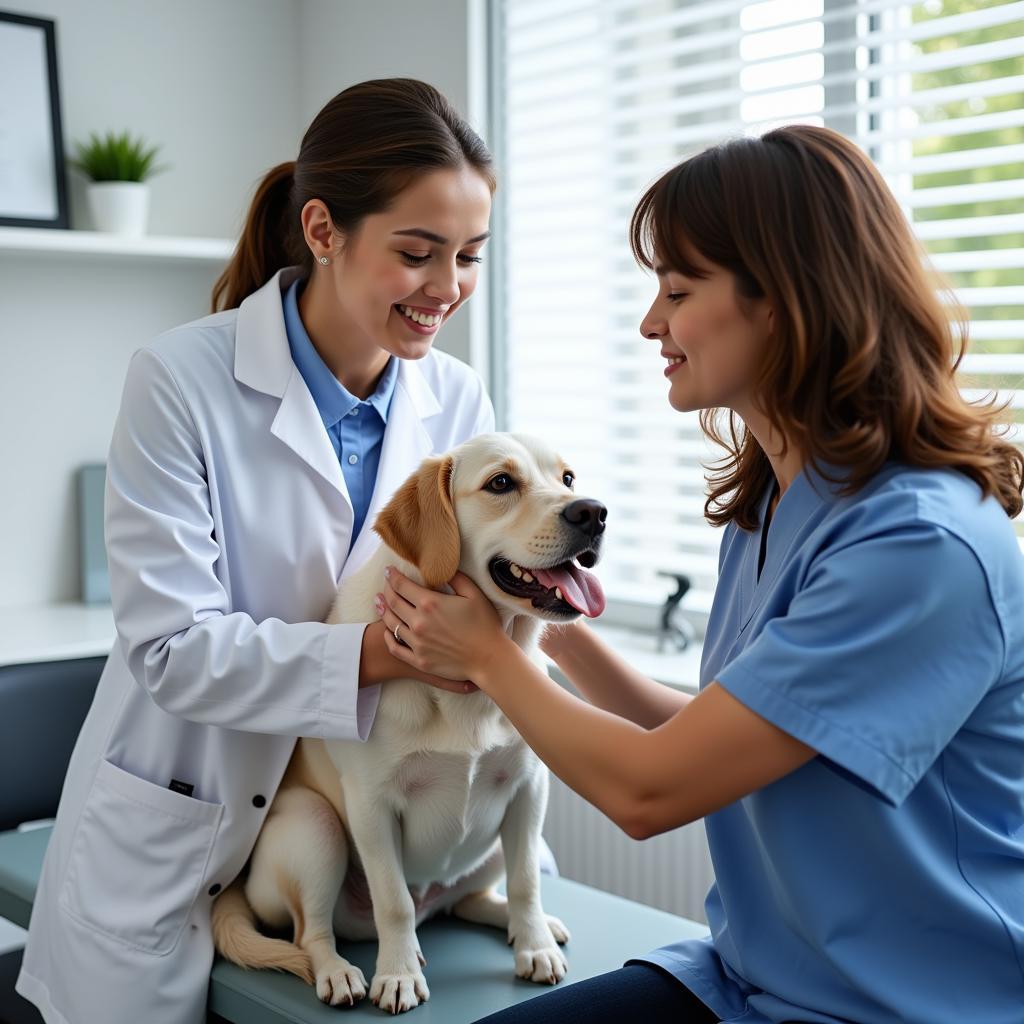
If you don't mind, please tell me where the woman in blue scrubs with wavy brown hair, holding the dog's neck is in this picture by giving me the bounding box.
[381,126,1024,1024]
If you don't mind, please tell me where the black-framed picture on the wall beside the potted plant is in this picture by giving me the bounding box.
[0,10,68,227]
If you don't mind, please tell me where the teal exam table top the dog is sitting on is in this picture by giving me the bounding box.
[0,828,708,1024]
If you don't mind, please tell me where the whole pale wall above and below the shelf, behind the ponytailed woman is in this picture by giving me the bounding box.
[0,0,482,607]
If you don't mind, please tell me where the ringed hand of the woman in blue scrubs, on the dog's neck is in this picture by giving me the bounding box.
[376,566,511,689]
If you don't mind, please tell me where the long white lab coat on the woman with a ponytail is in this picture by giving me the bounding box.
[17,268,494,1024]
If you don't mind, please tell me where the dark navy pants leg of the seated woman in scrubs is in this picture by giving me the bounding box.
[476,964,718,1024]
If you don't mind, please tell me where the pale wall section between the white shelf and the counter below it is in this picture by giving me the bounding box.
[0,255,218,606]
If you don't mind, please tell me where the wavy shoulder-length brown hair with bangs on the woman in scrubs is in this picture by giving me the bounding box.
[630,125,1024,529]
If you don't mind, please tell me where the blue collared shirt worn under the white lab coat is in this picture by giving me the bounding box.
[284,281,398,551]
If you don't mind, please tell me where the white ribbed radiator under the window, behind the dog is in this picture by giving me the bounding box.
[544,775,714,924]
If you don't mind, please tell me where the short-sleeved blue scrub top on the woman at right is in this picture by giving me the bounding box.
[630,465,1024,1024]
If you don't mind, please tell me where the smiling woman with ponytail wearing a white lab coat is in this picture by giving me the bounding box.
[17,80,494,1024]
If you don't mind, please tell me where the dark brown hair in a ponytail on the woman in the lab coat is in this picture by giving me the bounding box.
[211,78,496,312]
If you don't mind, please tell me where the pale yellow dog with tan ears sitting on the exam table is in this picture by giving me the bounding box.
[213,434,605,1013]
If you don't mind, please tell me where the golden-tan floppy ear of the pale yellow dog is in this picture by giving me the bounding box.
[374,456,462,588]
